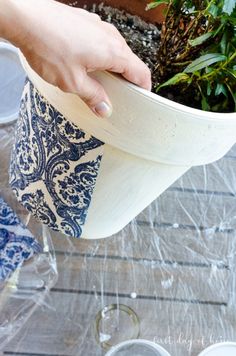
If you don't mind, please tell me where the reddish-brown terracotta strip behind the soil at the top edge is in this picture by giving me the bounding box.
[58,0,165,23]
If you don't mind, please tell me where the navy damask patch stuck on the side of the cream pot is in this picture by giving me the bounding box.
[10,80,103,237]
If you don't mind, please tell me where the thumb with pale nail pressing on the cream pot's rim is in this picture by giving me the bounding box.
[77,74,112,118]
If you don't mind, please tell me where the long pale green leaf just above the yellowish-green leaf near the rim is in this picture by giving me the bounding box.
[184,53,227,73]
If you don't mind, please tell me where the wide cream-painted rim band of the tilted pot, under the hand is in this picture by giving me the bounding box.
[21,54,236,166]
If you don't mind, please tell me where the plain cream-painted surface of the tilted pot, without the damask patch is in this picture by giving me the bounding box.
[10,56,236,238]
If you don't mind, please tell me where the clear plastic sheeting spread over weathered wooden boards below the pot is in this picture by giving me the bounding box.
[0,120,236,356]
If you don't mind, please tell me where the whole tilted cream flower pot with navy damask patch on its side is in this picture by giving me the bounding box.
[11,55,236,238]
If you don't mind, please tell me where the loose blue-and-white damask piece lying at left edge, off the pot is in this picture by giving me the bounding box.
[0,197,42,281]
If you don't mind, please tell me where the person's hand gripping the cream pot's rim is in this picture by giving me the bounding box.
[3,0,151,117]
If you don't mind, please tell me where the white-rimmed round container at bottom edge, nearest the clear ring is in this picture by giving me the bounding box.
[105,339,170,356]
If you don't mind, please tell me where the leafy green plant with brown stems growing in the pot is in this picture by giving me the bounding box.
[147,0,236,112]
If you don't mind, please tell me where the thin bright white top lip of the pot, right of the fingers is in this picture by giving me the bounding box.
[105,71,236,123]
